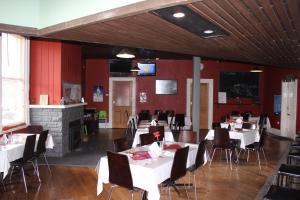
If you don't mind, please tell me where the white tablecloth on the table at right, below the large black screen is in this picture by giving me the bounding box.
[205,129,260,149]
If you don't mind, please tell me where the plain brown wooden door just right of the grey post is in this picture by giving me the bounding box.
[199,83,208,129]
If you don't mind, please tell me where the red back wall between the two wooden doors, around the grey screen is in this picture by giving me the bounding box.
[136,60,192,113]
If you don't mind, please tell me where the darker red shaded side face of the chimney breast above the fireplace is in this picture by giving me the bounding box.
[61,43,82,83]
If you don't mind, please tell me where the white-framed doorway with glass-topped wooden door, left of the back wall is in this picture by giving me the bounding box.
[109,77,136,128]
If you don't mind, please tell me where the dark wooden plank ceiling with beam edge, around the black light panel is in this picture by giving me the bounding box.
[2,0,300,68]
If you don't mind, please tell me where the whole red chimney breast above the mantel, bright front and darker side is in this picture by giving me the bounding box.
[29,39,82,105]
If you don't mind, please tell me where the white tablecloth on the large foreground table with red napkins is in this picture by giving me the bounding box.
[96,143,198,200]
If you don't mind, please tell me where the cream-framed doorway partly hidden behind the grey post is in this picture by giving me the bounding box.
[186,79,213,129]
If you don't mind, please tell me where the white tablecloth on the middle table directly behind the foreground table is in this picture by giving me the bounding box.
[132,121,174,148]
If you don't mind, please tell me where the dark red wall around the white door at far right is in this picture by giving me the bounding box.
[264,67,300,132]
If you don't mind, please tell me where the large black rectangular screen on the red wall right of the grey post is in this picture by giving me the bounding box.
[219,72,259,101]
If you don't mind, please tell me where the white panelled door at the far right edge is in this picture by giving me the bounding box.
[280,79,298,139]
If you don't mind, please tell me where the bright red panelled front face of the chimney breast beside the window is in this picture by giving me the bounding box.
[29,40,62,104]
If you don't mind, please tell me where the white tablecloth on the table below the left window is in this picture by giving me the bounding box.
[0,134,54,177]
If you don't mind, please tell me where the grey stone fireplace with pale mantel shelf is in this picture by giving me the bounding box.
[30,103,86,157]
